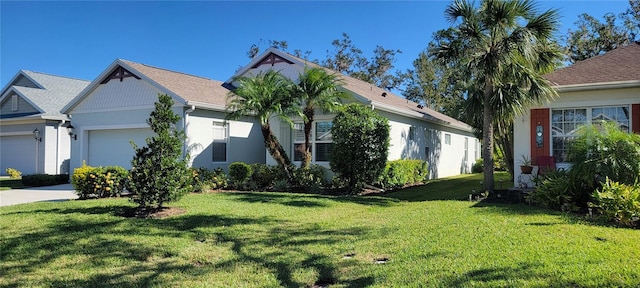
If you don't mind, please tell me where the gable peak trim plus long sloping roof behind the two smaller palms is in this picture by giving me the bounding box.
[227,48,472,132]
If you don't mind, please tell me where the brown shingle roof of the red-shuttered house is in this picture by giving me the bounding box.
[544,42,640,86]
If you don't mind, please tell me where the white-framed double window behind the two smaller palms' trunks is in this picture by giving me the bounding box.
[293,121,333,162]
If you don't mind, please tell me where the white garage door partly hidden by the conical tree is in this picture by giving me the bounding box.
[87,128,154,169]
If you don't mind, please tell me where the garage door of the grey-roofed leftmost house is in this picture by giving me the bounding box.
[0,135,36,175]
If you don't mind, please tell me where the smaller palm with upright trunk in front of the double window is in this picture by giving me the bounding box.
[294,67,346,168]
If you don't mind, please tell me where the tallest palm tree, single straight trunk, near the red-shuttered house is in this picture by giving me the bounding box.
[435,0,560,191]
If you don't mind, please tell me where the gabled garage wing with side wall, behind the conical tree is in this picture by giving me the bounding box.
[62,59,265,173]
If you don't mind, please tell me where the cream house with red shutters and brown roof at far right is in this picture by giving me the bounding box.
[514,43,640,187]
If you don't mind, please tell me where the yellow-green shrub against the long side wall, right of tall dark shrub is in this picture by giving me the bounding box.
[376,160,429,189]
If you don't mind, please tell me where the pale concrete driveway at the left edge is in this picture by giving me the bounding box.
[0,184,78,207]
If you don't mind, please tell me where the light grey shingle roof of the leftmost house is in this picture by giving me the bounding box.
[3,70,90,119]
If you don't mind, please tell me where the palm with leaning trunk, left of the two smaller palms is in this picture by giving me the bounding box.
[227,70,299,180]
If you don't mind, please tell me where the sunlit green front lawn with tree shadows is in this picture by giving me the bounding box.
[0,175,640,287]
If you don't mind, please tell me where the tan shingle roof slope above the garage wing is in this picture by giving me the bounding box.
[120,60,229,107]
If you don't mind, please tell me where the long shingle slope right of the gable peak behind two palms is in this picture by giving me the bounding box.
[262,49,473,131]
